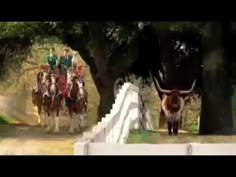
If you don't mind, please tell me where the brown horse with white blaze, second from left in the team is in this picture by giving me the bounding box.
[44,73,62,132]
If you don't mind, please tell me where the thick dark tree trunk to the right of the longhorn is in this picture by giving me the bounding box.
[199,23,233,134]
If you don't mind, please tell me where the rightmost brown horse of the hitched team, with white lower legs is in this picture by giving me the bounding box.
[66,76,86,133]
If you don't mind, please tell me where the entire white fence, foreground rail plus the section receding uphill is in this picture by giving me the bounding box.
[74,83,236,155]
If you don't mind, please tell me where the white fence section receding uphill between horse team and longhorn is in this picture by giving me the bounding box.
[75,83,152,152]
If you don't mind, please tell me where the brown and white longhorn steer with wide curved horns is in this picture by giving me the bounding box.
[153,74,196,135]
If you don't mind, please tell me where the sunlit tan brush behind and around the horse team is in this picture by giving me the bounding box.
[0,39,100,125]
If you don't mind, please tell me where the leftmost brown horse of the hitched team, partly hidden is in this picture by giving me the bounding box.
[32,70,47,126]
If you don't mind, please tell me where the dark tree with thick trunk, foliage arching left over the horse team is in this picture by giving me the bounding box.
[0,22,138,117]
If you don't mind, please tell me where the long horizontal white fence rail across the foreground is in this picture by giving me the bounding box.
[75,142,236,155]
